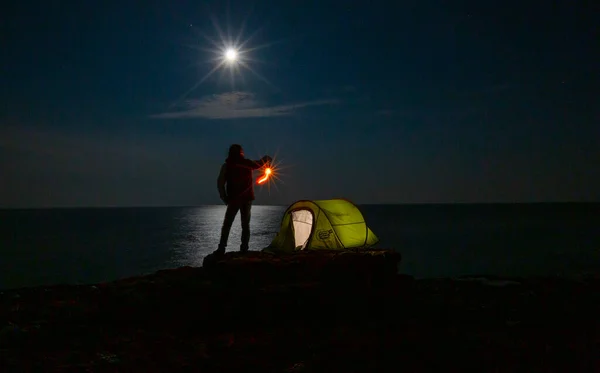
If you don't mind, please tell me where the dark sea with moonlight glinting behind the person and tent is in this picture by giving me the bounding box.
[0,203,600,289]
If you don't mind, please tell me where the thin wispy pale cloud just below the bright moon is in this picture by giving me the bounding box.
[150,92,339,119]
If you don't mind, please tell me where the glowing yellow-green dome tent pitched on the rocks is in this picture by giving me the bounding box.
[264,199,379,252]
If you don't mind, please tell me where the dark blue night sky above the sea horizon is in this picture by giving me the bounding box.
[0,0,600,207]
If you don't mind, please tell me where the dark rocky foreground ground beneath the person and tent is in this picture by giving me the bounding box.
[0,252,600,372]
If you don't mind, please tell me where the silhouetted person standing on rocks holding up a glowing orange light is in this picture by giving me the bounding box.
[215,144,272,254]
